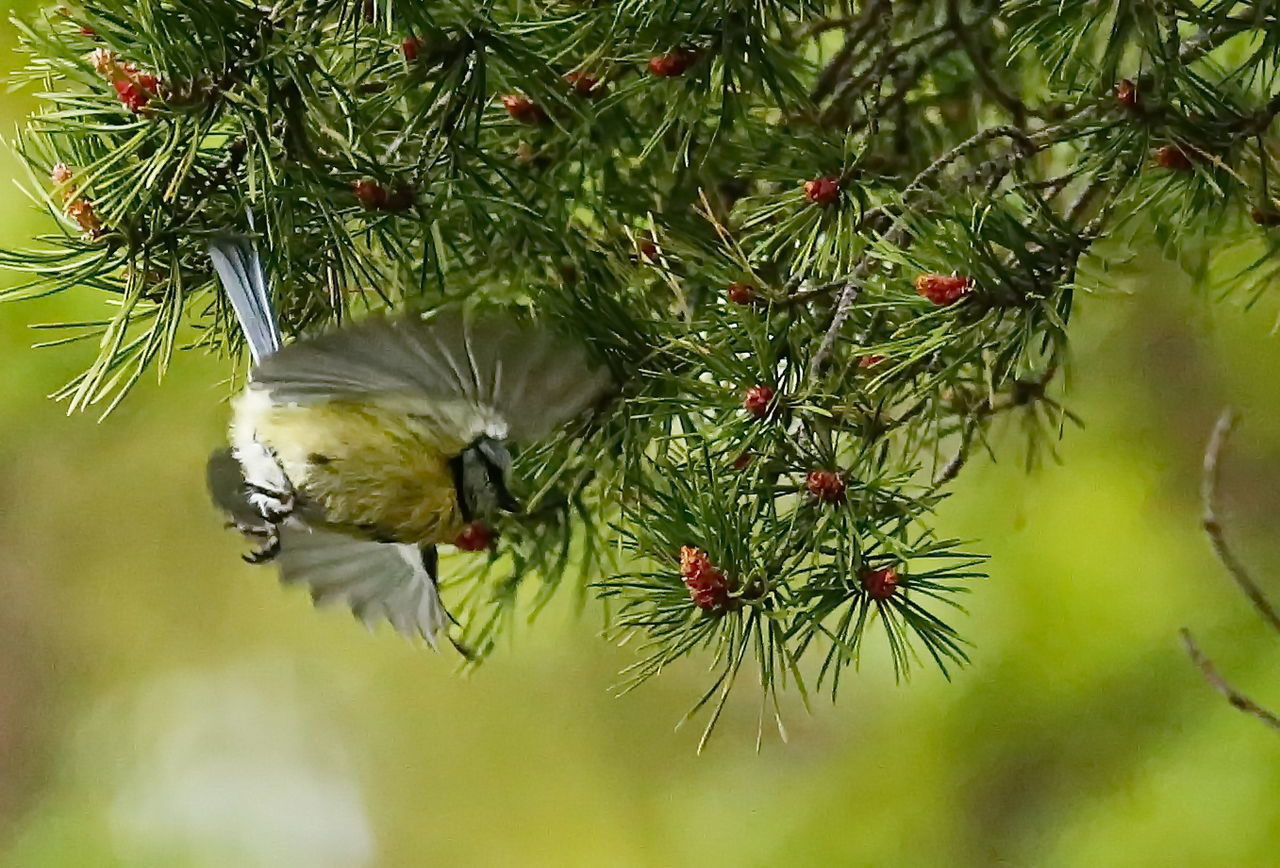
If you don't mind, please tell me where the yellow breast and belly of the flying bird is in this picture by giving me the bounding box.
[245,401,467,545]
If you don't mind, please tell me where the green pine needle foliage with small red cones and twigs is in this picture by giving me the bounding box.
[10,0,1280,747]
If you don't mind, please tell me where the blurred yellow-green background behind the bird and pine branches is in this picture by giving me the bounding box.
[0,4,1280,867]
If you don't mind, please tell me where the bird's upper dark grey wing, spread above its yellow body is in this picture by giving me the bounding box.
[252,312,611,440]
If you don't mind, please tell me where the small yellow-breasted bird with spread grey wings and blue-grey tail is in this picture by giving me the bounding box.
[207,237,611,648]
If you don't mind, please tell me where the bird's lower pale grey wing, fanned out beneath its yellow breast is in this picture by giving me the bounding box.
[275,526,449,648]
